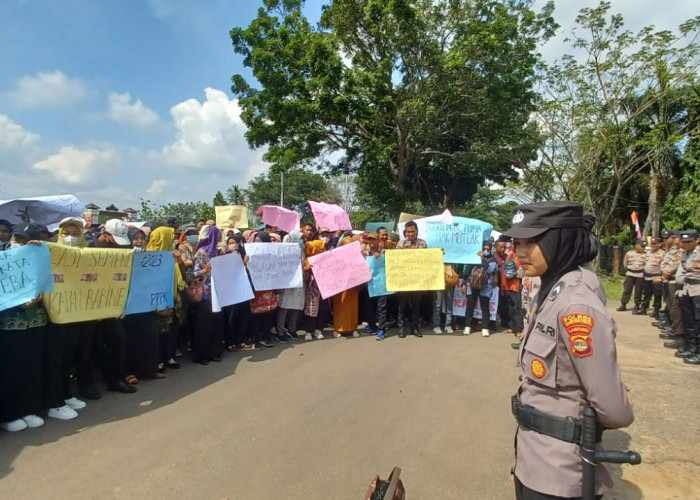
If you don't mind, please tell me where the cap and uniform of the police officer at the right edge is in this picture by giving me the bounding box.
[676,229,700,365]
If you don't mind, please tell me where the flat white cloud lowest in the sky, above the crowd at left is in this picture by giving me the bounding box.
[32,146,119,186]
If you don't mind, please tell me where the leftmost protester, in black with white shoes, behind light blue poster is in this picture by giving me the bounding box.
[0,224,47,432]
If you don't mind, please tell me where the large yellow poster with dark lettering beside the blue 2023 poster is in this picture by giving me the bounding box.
[44,243,134,324]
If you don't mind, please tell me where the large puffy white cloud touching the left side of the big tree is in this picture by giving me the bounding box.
[152,88,263,176]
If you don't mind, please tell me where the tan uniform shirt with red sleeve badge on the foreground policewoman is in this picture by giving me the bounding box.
[514,268,643,497]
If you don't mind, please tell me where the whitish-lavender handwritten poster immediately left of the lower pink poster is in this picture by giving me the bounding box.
[245,243,303,292]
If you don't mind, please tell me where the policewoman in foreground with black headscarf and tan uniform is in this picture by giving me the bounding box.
[504,202,634,499]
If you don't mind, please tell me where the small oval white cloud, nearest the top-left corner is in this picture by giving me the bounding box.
[6,71,87,108]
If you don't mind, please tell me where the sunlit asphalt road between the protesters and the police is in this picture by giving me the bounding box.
[0,313,700,500]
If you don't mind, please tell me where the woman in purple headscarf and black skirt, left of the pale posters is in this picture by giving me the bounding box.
[192,224,223,365]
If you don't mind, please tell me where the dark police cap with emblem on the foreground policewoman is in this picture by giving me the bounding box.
[503,201,587,239]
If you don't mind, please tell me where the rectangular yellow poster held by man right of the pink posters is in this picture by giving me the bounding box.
[386,248,445,292]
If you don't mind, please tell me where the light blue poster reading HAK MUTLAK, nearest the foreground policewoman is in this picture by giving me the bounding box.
[425,217,493,264]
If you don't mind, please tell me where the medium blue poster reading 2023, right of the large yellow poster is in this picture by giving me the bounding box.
[124,251,175,314]
